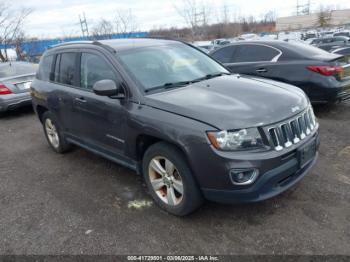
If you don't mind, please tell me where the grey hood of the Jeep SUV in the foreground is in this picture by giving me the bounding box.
[145,75,308,130]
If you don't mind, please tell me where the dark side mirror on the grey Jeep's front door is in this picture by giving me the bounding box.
[92,79,125,98]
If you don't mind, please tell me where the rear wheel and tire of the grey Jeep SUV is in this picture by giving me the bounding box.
[41,111,71,154]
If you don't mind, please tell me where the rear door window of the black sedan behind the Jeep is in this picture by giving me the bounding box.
[233,45,280,62]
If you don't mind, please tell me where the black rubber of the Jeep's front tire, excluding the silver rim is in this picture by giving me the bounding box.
[142,142,203,216]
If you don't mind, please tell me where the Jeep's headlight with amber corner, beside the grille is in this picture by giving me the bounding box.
[207,128,264,151]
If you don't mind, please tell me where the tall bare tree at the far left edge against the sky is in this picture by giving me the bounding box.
[0,1,32,62]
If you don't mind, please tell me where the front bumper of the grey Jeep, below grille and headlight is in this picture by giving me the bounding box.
[191,129,320,203]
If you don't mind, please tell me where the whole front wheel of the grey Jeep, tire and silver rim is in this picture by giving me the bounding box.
[142,142,203,216]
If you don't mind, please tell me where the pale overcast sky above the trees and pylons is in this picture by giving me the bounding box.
[9,0,350,38]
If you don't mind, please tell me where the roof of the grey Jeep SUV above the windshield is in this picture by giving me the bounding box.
[54,38,183,51]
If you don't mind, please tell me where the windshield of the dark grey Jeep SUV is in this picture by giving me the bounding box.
[117,44,229,92]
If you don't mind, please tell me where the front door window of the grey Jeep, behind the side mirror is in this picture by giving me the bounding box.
[80,53,117,90]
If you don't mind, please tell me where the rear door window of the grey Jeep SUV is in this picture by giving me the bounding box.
[55,52,77,86]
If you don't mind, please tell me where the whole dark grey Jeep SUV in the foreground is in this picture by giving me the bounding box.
[31,39,319,215]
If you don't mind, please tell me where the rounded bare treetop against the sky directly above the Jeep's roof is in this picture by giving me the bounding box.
[114,9,138,35]
